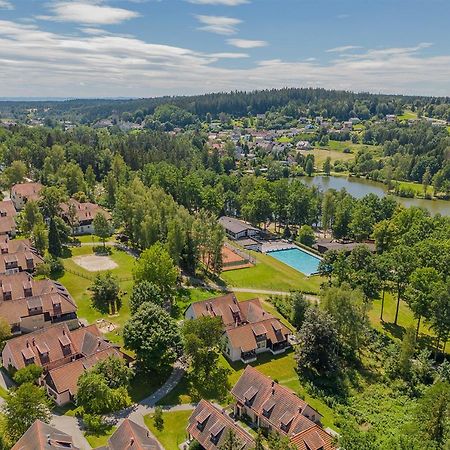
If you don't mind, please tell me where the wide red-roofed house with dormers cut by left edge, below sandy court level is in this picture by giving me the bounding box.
[0,272,78,334]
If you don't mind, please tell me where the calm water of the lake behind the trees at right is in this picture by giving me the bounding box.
[302,175,450,216]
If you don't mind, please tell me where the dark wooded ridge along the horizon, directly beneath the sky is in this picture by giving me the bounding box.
[0,88,450,123]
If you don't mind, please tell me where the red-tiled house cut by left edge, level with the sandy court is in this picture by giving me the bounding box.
[0,236,44,274]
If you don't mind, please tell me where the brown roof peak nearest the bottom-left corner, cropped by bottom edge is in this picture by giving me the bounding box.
[11,420,79,450]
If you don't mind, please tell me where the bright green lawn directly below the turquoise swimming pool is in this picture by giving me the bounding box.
[222,252,322,293]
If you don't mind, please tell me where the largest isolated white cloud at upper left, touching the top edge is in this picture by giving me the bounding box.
[38,0,139,25]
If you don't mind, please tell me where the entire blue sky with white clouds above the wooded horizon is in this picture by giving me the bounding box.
[0,0,450,97]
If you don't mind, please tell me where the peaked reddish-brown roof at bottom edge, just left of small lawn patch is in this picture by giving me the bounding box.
[98,419,161,450]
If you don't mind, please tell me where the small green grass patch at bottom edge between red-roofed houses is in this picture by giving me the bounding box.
[144,411,192,450]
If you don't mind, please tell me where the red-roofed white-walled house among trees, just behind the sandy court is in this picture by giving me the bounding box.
[61,198,111,235]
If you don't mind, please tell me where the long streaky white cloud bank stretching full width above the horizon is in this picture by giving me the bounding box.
[0,20,450,97]
